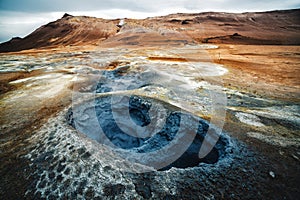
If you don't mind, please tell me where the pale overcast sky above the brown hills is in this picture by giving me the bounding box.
[0,0,300,42]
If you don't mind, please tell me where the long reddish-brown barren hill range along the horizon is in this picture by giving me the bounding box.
[0,9,300,52]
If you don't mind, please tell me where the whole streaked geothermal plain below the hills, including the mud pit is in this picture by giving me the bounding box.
[0,41,300,199]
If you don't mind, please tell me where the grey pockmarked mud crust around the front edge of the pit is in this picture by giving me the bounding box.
[22,105,272,199]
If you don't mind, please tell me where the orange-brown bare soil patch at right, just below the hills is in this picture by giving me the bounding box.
[209,45,300,101]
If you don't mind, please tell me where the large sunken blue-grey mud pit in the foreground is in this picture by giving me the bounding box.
[67,95,231,170]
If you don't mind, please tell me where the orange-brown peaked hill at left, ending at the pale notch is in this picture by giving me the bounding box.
[0,14,118,52]
